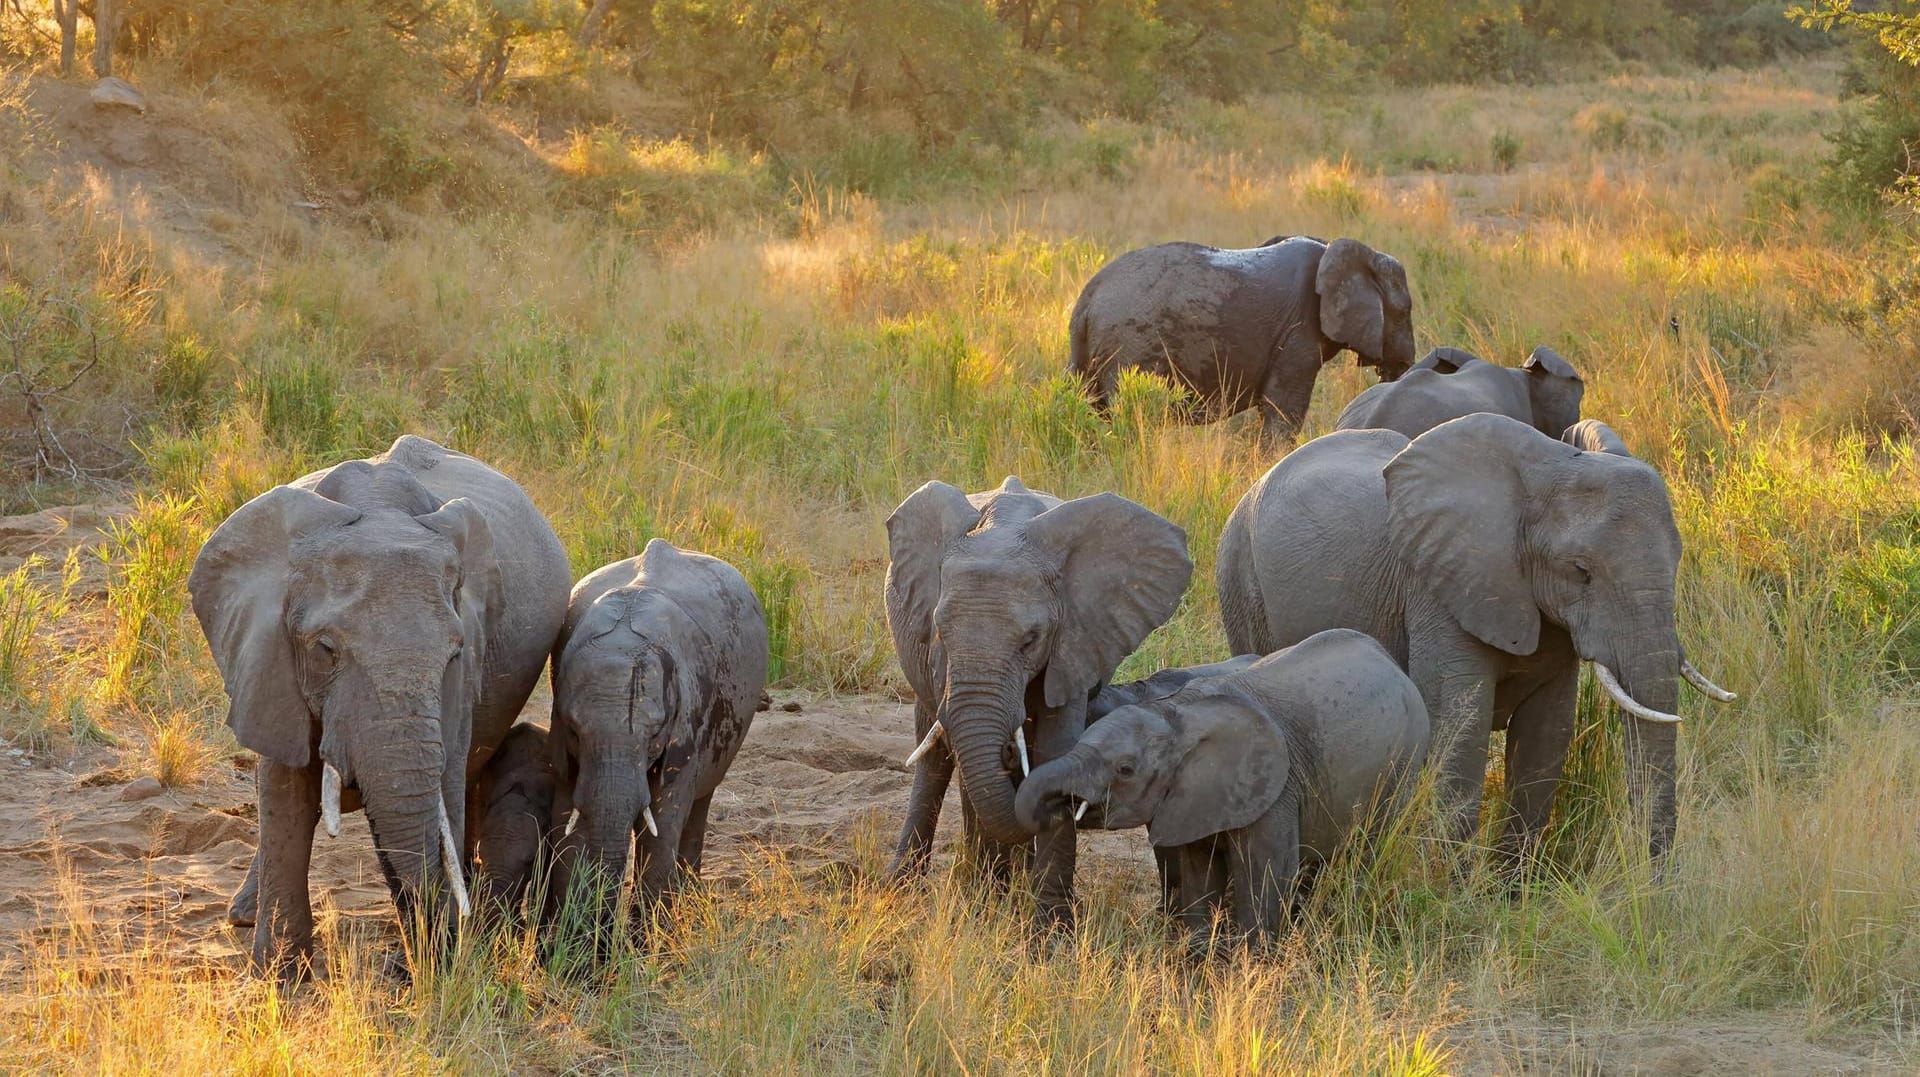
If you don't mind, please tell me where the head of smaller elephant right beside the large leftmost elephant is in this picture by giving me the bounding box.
[553,583,707,881]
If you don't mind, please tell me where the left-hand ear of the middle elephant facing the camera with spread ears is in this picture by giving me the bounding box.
[887,482,979,699]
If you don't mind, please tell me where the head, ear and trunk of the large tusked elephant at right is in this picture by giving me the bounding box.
[1384,413,1720,852]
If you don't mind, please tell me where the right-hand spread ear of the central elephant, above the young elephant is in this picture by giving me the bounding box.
[1027,493,1194,706]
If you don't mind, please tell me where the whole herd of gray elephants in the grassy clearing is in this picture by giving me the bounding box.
[188,236,1732,975]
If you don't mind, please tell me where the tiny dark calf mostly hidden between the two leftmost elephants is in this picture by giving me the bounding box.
[468,722,561,921]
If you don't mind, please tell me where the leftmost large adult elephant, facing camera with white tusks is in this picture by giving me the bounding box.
[186,436,568,975]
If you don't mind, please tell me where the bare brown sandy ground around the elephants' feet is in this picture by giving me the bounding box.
[0,507,1908,1077]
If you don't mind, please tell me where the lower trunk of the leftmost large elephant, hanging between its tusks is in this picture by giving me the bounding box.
[349,716,467,923]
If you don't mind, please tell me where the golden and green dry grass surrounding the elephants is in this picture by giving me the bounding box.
[0,56,1920,1073]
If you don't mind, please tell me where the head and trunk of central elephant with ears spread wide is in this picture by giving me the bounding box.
[887,478,1192,845]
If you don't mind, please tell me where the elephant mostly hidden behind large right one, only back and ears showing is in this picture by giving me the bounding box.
[1334,347,1586,438]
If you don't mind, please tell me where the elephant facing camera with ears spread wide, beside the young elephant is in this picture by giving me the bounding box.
[887,476,1192,925]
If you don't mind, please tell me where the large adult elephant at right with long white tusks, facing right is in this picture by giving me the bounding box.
[1217,413,1724,856]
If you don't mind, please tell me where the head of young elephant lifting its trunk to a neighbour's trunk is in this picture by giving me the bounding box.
[1014,685,1292,847]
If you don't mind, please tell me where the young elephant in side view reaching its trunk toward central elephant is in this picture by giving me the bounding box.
[1014,628,1428,943]
